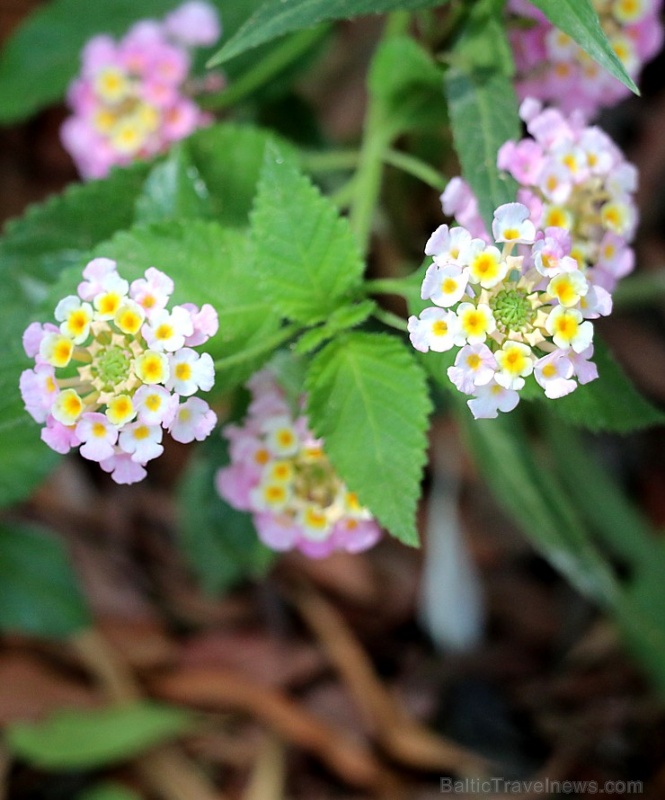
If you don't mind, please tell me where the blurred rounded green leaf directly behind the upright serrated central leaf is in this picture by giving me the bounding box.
[186,123,295,227]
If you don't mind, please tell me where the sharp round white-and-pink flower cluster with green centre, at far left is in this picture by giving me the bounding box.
[20,258,218,483]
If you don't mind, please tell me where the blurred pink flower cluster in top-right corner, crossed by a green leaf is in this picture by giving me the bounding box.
[507,0,663,118]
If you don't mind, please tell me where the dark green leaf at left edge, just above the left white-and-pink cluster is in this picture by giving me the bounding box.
[0,163,149,290]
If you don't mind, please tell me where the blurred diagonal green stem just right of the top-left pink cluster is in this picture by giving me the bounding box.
[198,25,329,111]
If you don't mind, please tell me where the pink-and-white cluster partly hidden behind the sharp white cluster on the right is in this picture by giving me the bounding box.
[441,99,638,292]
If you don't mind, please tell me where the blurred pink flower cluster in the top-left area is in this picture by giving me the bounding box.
[61,0,221,178]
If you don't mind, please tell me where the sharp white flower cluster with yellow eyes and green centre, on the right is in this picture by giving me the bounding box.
[408,203,612,419]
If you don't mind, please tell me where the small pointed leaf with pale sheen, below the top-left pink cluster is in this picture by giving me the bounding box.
[135,144,212,222]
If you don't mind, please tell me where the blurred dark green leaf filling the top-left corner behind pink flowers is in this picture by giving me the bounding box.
[0,0,220,122]
